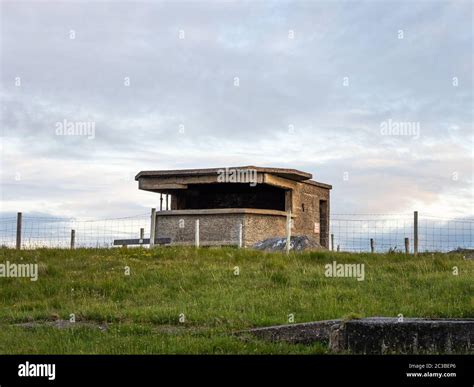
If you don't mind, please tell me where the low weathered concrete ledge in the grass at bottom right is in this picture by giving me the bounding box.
[248,317,474,354]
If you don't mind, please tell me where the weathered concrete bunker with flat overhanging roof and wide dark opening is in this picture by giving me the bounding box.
[135,166,332,248]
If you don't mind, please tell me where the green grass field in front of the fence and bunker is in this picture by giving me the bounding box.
[0,247,474,354]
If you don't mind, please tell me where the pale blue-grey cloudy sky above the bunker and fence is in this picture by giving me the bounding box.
[0,0,474,217]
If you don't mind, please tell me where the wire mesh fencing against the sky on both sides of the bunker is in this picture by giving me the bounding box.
[0,213,474,252]
